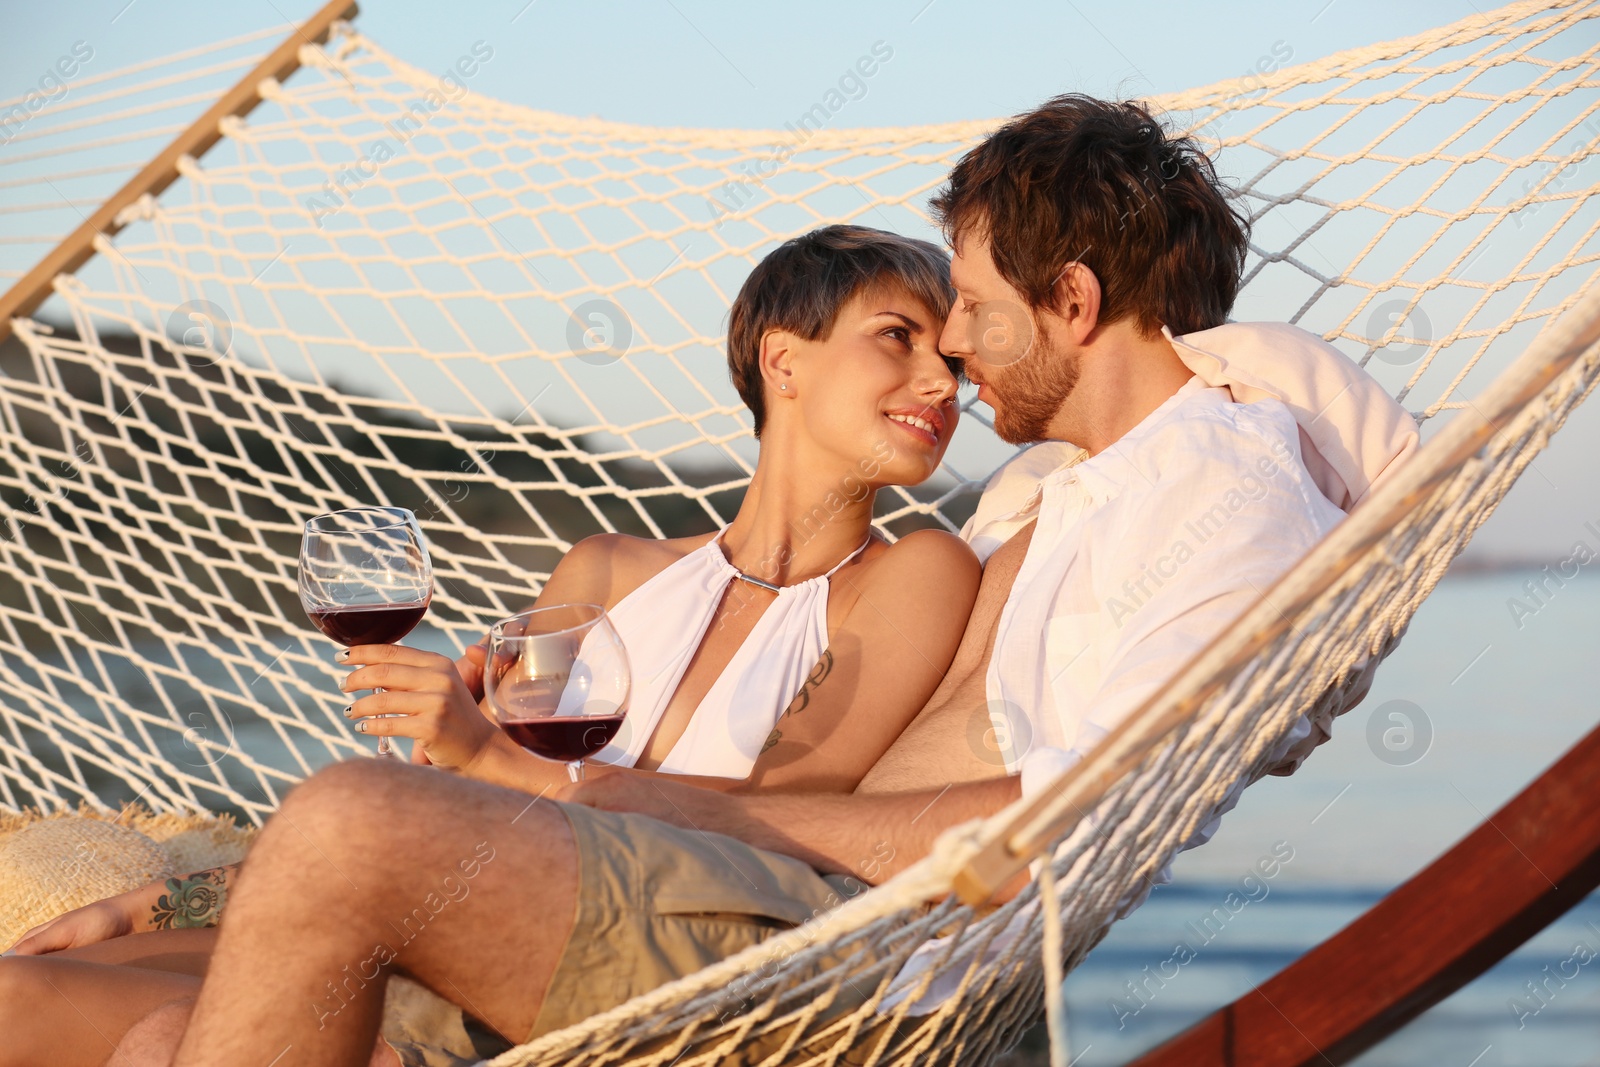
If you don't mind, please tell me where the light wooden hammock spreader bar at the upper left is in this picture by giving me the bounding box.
[0,0,357,342]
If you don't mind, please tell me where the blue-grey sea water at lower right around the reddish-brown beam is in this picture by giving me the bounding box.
[1066,572,1600,1067]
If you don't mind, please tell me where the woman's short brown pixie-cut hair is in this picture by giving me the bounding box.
[728,226,960,437]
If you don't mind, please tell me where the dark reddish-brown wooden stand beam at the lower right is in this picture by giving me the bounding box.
[1130,716,1600,1067]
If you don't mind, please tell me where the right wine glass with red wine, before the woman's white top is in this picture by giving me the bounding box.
[483,605,632,782]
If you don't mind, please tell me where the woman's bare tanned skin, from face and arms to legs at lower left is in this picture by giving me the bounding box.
[0,285,979,1067]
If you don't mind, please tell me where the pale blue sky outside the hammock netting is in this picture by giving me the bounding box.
[0,0,1600,563]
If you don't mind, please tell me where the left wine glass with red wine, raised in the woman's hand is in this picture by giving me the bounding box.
[299,507,434,758]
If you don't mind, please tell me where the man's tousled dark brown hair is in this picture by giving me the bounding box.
[930,94,1250,338]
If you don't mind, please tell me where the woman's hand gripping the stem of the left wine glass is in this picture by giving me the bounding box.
[341,645,501,774]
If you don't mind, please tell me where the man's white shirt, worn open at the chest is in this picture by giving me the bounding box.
[880,378,1344,1014]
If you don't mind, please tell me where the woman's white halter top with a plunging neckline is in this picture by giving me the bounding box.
[594,528,872,777]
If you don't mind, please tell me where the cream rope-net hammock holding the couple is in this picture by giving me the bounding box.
[0,0,1600,1067]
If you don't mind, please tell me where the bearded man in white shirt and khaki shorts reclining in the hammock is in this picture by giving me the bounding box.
[144,96,1342,1067]
